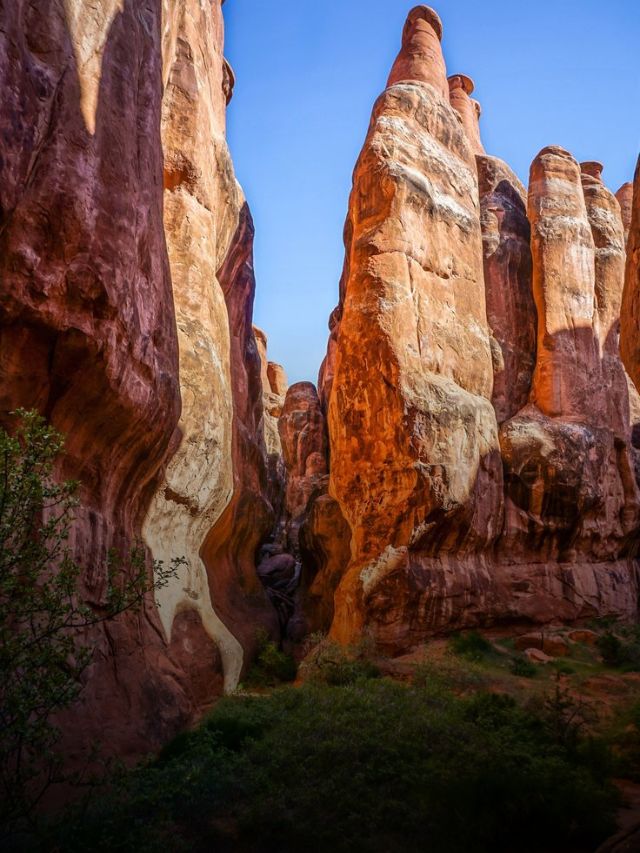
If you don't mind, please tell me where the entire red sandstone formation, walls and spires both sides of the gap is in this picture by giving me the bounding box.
[0,0,640,755]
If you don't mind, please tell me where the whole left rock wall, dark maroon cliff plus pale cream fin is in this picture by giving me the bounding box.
[0,0,275,753]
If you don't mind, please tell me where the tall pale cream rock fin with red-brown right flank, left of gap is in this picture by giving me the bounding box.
[144,2,273,689]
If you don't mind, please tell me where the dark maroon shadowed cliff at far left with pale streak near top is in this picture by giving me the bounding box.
[0,0,193,750]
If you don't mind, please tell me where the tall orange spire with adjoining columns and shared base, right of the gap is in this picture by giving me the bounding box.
[319,6,639,652]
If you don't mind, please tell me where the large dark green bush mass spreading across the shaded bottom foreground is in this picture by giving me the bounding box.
[53,679,616,853]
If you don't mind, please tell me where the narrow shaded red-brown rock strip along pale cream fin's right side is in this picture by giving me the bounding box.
[200,204,282,672]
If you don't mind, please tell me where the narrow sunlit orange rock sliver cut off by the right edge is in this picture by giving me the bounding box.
[620,158,640,389]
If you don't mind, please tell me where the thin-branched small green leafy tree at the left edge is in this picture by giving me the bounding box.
[0,410,184,832]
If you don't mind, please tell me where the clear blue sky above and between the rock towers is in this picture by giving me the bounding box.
[224,0,640,382]
